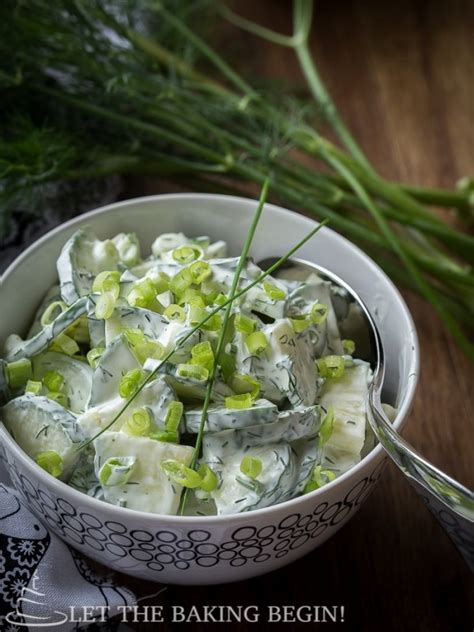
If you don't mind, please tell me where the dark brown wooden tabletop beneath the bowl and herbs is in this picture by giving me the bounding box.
[119,0,474,632]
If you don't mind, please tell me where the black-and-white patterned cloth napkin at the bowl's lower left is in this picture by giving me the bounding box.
[0,460,137,632]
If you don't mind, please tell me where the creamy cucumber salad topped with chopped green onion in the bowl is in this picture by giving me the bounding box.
[0,228,386,515]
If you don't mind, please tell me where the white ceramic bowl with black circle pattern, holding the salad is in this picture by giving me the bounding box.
[0,194,418,584]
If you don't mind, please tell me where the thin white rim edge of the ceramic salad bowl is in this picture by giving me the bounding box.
[0,192,420,526]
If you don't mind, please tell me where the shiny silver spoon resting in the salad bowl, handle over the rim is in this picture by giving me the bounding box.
[258,257,474,571]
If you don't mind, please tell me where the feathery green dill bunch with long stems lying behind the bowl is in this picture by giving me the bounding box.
[0,0,474,359]
